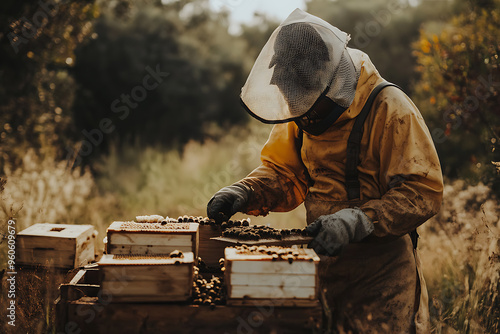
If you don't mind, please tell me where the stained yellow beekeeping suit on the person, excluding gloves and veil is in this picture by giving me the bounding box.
[241,50,443,333]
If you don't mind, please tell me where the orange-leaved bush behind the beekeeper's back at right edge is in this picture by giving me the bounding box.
[413,3,500,190]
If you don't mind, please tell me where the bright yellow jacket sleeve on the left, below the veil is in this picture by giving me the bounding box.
[240,122,307,216]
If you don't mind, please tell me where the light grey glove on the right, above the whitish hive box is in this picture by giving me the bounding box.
[306,208,374,256]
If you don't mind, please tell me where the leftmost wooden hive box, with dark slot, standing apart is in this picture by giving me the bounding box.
[16,224,95,269]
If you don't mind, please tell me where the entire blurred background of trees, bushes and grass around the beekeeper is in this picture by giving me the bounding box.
[0,0,500,333]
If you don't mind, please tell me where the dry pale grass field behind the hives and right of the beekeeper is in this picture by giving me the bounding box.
[0,122,500,334]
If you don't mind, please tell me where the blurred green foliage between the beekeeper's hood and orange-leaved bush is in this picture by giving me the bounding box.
[307,0,454,91]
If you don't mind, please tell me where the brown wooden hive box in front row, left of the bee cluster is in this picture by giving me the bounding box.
[98,252,194,303]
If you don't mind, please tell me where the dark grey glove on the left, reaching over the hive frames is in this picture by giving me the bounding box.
[207,183,252,223]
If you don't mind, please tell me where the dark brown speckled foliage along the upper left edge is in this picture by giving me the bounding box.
[0,0,98,168]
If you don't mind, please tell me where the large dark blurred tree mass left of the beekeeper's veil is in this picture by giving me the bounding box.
[74,0,252,163]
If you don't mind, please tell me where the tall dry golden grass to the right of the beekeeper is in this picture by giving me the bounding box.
[420,181,500,334]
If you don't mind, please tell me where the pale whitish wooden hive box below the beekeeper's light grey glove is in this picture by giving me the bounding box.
[225,246,319,304]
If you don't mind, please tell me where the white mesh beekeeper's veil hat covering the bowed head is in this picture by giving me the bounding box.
[241,9,357,123]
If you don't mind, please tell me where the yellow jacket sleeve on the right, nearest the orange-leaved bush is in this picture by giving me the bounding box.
[360,88,443,237]
